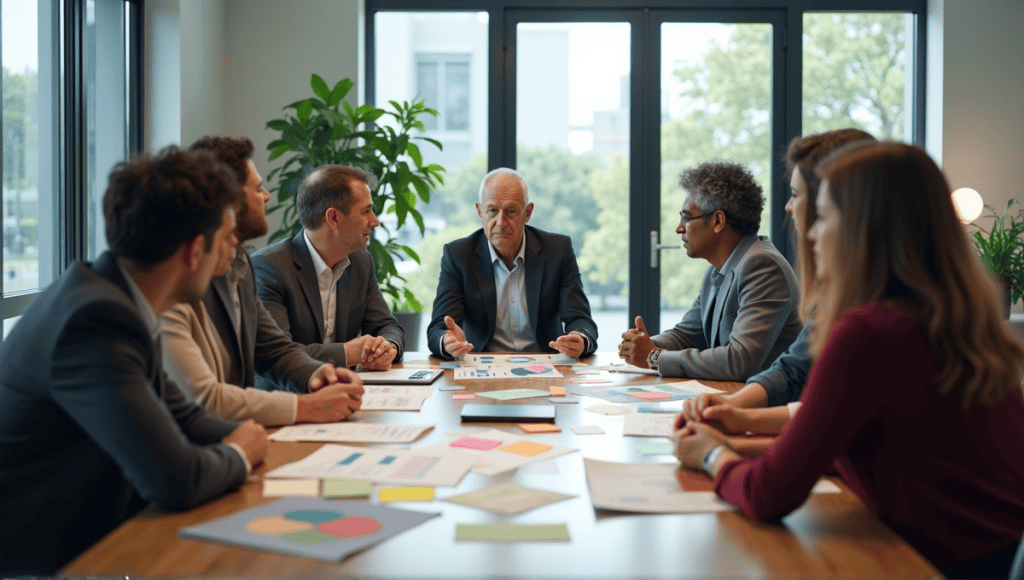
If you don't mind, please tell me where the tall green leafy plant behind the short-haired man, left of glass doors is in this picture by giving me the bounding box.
[266,75,444,313]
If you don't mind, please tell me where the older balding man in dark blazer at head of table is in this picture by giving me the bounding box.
[427,168,597,359]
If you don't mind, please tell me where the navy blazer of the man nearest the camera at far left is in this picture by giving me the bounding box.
[0,252,246,576]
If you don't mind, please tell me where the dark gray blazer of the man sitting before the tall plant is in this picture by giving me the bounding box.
[253,231,406,367]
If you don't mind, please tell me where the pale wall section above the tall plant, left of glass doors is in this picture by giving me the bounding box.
[223,0,365,247]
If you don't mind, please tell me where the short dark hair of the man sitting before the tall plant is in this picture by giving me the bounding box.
[296,165,376,230]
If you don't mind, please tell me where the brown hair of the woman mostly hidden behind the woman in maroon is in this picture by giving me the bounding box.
[785,128,877,323]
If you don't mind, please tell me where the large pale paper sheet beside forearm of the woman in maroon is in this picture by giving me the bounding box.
[583,458,733,513]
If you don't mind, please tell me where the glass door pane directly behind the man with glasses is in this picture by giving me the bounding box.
[660,23,772,331]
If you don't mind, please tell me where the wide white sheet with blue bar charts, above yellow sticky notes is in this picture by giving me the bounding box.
[265,445,478,487]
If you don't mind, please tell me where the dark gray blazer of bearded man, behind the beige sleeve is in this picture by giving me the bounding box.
[203,246,323,392]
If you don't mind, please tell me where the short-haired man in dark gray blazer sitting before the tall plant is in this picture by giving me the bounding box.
[253,165,406,369]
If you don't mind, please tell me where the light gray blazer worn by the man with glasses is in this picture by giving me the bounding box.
[651,234,803,381]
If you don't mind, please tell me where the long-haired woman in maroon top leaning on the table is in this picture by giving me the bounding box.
[675,142,1024,578]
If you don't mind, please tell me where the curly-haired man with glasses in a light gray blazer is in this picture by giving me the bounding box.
[620,161,802,380]
